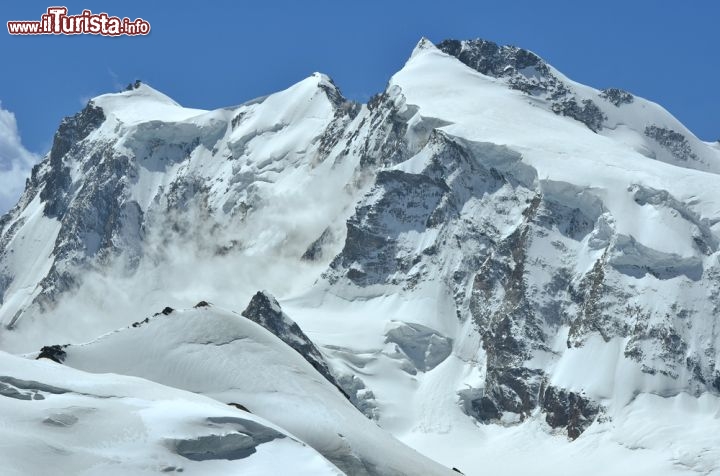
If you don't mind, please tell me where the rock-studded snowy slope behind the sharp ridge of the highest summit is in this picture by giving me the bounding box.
[434,39,720,173]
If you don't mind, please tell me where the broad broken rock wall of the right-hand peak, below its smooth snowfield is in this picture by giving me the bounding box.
[325,107,718,438]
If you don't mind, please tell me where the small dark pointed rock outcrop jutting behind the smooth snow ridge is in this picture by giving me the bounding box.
[242,291,344,393]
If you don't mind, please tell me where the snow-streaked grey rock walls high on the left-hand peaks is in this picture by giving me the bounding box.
[0,74,424,325]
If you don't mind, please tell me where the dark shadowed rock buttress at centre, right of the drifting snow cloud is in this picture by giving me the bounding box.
[325,133,517,289]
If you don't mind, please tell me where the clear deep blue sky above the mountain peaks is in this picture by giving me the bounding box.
[0,0,720,210]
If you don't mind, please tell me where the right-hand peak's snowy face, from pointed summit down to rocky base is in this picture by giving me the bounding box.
[324,42,720,438]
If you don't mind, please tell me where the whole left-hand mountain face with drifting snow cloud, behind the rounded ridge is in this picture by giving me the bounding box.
[0,64,436,350]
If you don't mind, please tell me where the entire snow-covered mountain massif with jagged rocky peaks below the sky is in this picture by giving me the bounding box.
[0,39,720,474]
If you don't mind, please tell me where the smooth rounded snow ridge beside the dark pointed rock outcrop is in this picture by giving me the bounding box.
[52,307,450,475]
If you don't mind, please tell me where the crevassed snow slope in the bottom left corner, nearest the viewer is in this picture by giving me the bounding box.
[0,352,343,475]
